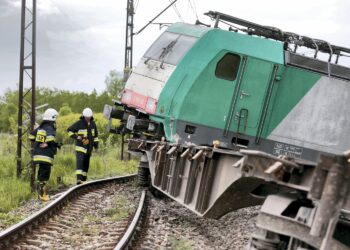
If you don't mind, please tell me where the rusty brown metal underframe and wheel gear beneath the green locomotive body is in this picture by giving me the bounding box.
[128,139,350,250]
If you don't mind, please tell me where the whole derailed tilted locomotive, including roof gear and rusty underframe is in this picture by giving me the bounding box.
[104,11,350,249]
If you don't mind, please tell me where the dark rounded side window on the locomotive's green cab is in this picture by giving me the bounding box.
[215,53,241,81]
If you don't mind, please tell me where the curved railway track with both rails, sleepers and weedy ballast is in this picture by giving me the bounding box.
[0,175,147,249]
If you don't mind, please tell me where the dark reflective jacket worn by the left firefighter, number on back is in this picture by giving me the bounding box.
[29,121,57,165]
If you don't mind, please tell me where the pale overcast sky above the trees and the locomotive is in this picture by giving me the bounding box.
[0,0,350,94]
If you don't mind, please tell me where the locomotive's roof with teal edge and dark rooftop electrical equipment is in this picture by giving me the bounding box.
[167,18,350,80]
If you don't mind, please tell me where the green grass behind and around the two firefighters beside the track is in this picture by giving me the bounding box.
[0,134,138,214]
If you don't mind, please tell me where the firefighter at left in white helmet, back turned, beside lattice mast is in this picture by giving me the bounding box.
[29,108,61,201]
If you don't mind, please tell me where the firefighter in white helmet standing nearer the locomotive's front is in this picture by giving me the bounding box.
[67,108,98,185]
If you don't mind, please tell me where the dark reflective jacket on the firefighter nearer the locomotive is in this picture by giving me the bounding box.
[67,116,98,154]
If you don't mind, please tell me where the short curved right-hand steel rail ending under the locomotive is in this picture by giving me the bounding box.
[114,190,147,250]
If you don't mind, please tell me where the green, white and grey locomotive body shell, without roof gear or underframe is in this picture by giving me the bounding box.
[118,16,350,164]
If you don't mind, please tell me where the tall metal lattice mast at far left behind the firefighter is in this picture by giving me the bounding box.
[17,0,36,188]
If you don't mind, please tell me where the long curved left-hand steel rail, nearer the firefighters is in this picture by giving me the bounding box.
[0,174,137,249]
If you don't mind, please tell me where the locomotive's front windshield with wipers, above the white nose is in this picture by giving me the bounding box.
[144,32,197,65]
